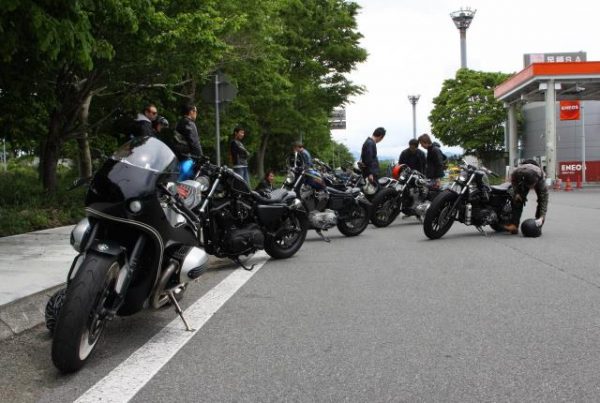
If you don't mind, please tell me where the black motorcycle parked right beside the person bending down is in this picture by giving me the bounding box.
[423,164,512,239]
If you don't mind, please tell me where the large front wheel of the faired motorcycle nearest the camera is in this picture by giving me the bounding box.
[52,253,120,373]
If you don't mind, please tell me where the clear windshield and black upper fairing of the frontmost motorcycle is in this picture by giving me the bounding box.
[86,137,178,210]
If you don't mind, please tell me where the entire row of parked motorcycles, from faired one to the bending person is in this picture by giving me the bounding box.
[46,137,511,373]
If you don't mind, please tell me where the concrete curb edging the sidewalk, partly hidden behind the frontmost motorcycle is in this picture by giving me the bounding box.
[0,256,231,341]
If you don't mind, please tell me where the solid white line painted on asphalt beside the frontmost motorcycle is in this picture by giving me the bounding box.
[75,252,268,403]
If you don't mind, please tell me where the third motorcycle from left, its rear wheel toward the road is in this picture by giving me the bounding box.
[283,158,371,242]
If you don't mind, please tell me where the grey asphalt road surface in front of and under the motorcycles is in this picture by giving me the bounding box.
[0,189,600,402]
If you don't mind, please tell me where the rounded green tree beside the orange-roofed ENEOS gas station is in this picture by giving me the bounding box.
[429,69,510,161]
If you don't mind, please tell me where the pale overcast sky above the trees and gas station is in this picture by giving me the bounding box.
[333,0,600,158]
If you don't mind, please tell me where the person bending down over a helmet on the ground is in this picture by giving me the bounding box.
[504,160,549,234]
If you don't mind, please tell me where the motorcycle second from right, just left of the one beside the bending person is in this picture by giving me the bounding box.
[371,165,439,227]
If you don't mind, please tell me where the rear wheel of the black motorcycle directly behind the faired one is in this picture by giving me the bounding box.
[265,213,308,259]
